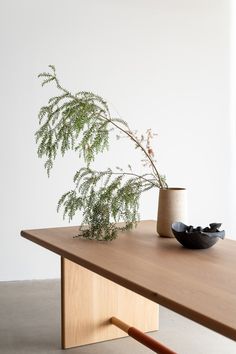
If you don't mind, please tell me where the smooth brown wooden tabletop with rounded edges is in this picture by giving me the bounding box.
[21,221,236,340]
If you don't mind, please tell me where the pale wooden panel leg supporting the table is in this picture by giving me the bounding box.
[61,258,158,349]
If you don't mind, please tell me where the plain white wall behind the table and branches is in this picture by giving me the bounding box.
[0,0,233,280]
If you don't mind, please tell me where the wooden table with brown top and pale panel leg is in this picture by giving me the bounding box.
[21,221,236,348]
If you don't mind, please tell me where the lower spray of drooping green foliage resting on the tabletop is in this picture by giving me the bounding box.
[58,168,155,240]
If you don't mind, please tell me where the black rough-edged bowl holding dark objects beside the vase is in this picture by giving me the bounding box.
[171,222,225,249]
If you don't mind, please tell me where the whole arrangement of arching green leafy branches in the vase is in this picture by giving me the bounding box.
[36,65,168,240]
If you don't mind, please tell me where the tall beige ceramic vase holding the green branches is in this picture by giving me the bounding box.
[157,188,187,237]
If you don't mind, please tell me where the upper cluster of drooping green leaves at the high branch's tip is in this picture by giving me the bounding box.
[36,65,110,175]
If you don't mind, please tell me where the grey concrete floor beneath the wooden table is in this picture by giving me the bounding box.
[0,280,236,354]
